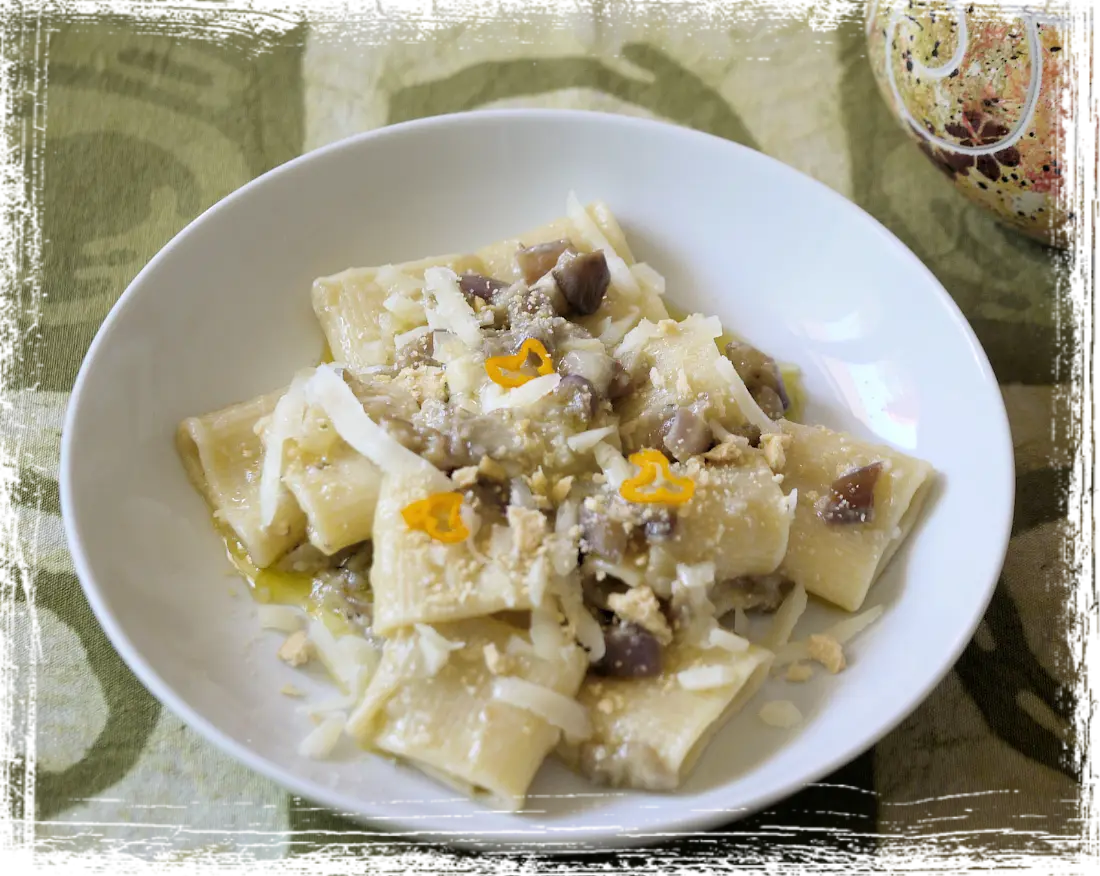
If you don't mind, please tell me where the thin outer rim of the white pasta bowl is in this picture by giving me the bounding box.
[58,108,1015,855]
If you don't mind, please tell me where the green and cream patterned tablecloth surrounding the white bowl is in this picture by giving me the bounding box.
[0,0,1100,876]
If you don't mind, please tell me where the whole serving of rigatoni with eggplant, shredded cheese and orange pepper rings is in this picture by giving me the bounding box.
[178,195,934,812]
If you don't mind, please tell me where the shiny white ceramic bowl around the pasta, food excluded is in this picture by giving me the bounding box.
[61,110,1013,853]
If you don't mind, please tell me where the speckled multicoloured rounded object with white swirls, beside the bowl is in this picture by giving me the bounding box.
[867,0,1100,255]
